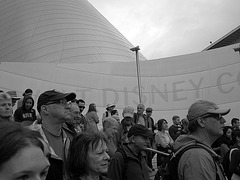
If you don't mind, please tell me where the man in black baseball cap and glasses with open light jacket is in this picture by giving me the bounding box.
[32,90,76,180]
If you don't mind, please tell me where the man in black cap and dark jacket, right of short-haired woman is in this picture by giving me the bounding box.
[107,124,153,180]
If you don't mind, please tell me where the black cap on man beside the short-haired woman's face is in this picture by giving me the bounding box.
[128,124,153,138]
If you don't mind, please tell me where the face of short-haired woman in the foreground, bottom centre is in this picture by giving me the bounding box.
[88,141,110,174]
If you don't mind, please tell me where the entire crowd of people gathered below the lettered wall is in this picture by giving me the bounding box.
[0,89,240,180]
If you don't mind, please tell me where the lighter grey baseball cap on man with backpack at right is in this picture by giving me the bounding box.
[187,100,230,121]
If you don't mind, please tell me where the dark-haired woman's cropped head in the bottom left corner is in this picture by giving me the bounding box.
[0,122,50,180]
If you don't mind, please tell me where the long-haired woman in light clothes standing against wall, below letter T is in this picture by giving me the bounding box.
[85,103,99,132]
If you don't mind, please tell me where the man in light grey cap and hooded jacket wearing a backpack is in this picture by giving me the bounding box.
[174,100,230,180]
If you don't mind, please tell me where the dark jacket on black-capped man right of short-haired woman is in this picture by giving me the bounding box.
[107,145,150,180]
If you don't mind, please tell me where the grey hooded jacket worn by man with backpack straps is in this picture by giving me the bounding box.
[174,135,226,180]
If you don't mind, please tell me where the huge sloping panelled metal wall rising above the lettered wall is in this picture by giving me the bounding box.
[0,0,145,63]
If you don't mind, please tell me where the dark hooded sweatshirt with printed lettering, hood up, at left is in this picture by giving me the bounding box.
[14,96,37,122]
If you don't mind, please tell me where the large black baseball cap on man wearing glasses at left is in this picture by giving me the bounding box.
[37,90,76,111]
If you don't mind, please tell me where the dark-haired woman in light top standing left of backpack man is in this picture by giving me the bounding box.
[155,119,174,168]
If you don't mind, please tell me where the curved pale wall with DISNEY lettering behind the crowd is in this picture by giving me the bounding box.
[0,45,240,124]
